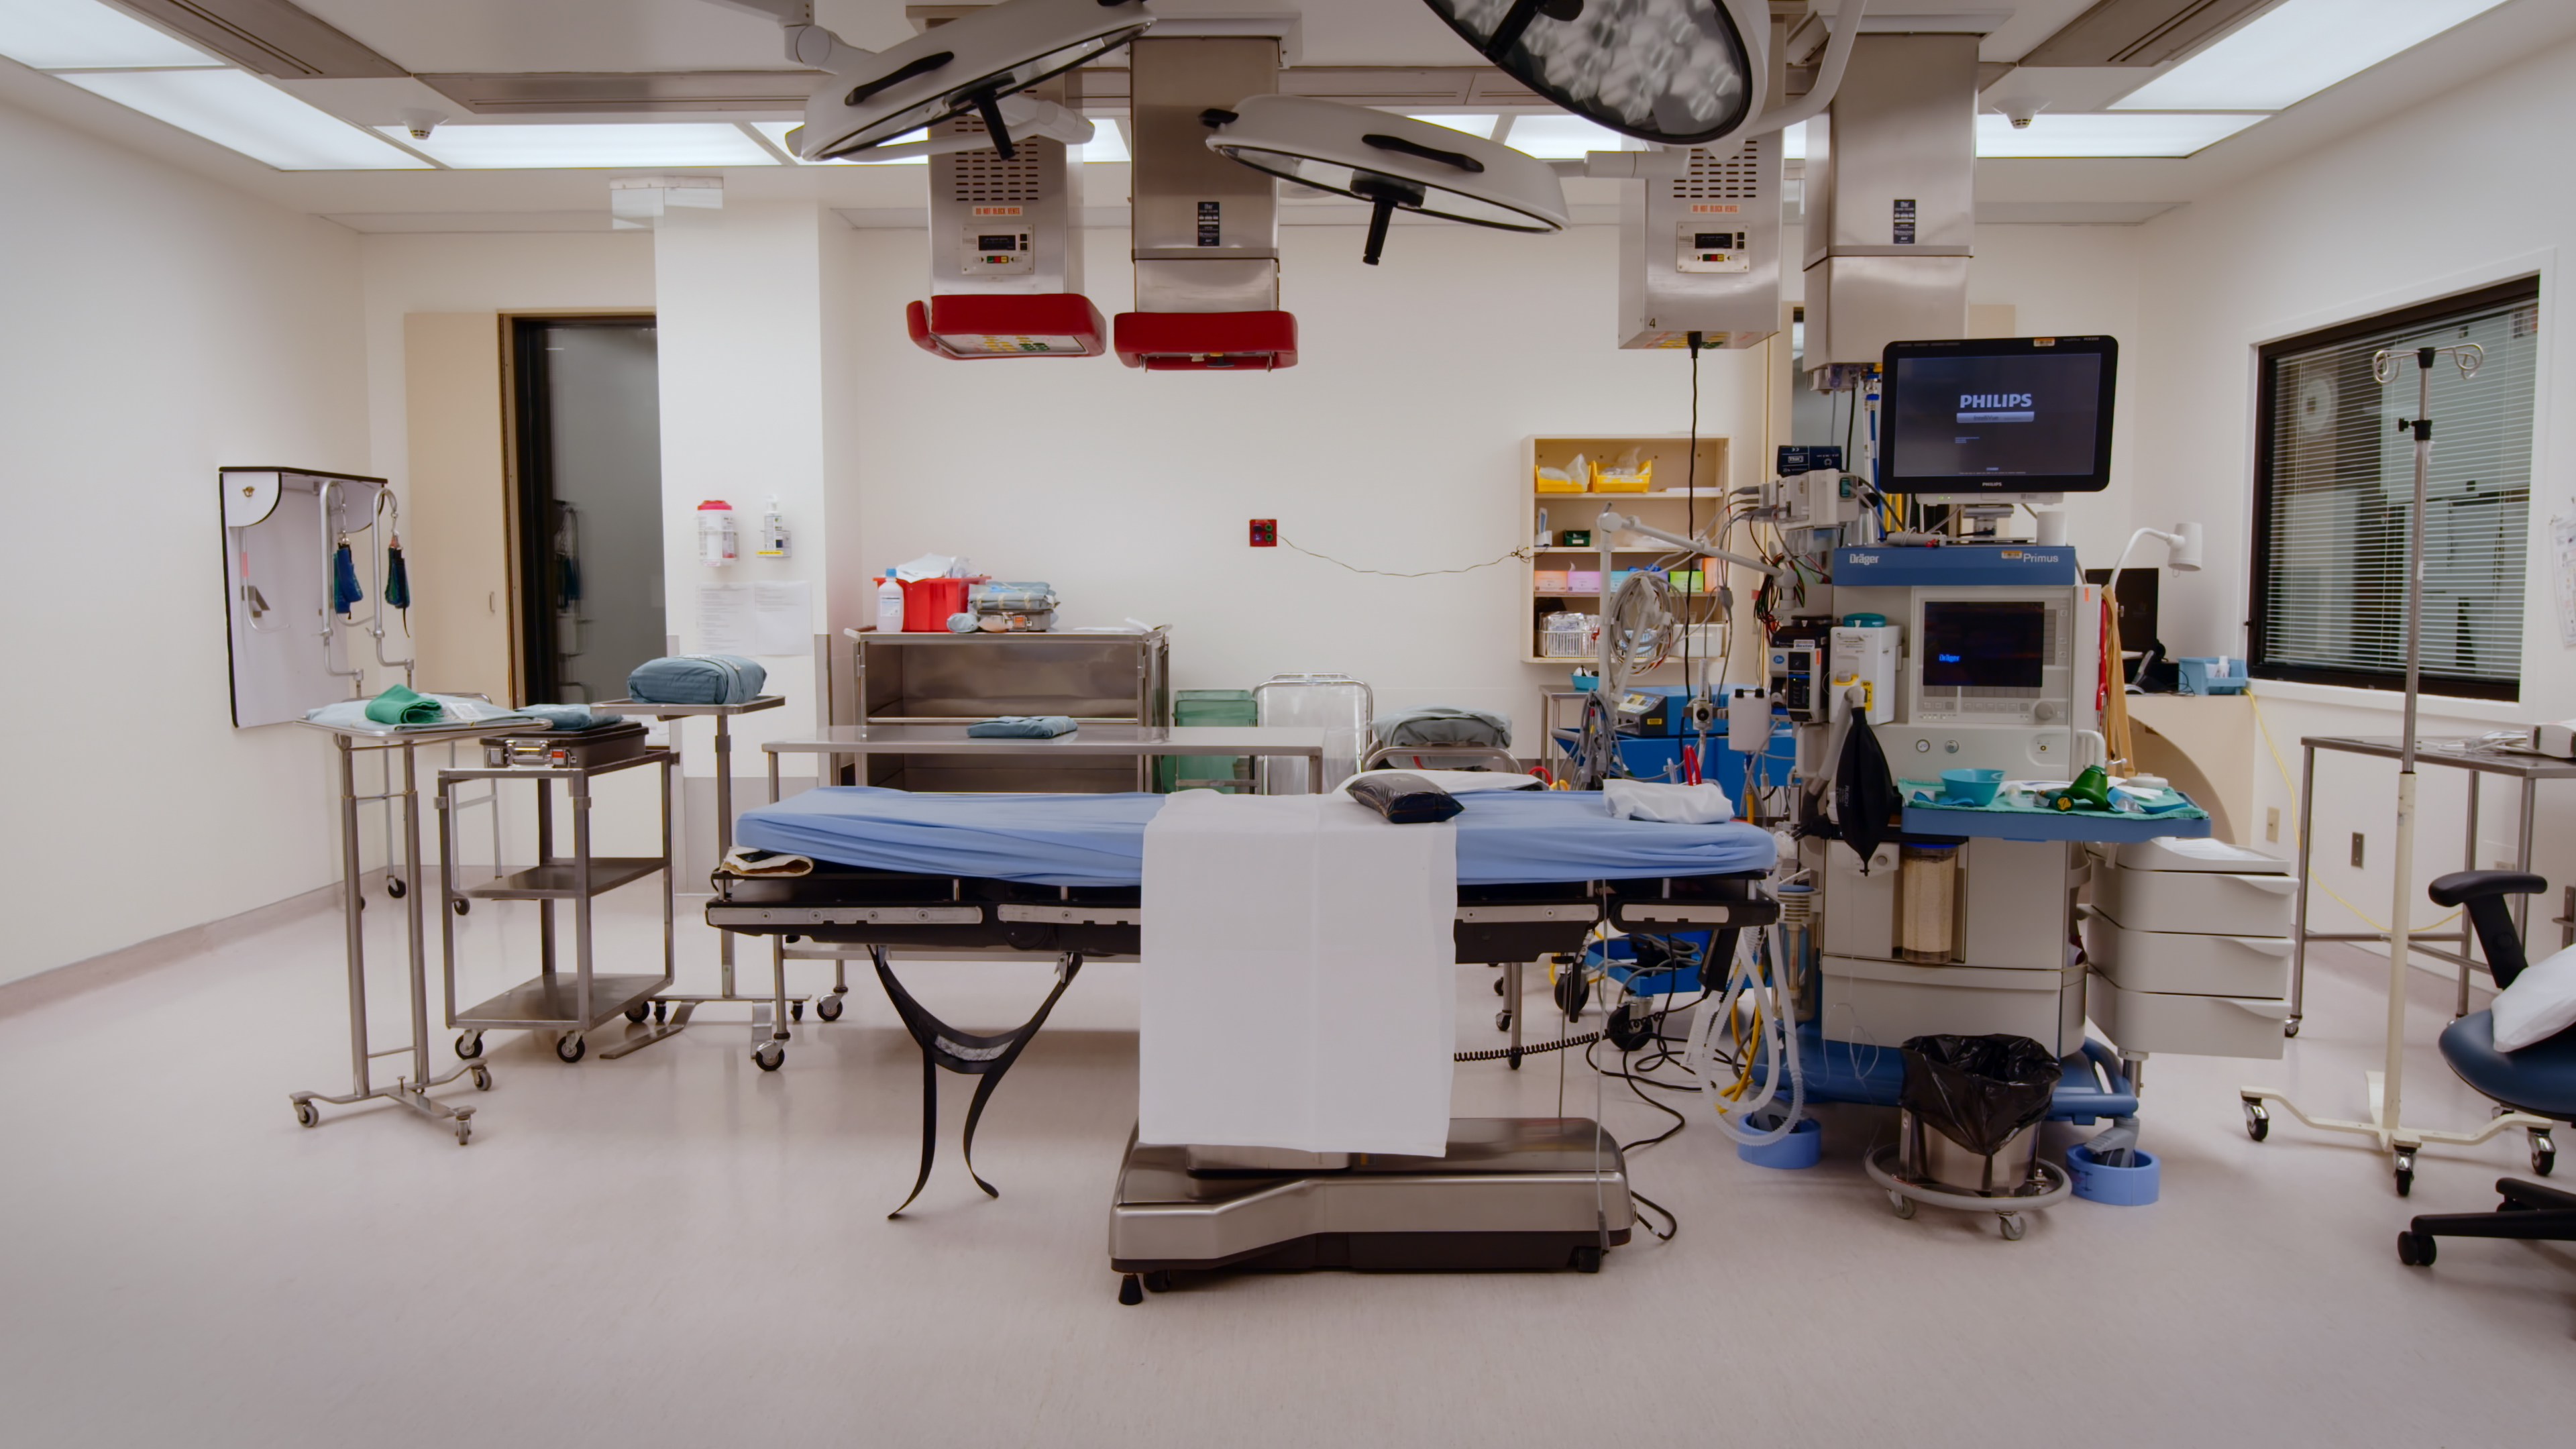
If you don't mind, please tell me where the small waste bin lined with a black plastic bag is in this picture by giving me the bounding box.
[1896,1034,2061,1194]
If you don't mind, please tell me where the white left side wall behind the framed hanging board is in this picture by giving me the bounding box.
[0,106,374,979]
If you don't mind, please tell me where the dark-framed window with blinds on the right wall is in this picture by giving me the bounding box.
[2251,278,2540,699]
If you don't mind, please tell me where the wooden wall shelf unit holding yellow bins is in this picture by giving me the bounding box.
[1520,433,1729,667]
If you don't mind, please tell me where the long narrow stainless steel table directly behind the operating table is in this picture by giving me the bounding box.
[726,722,1324,1073]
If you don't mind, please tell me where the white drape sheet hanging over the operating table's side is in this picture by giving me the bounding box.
[1136,789,1458,1158]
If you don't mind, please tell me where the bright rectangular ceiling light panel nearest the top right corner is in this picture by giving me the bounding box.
[2112,0,2502,111]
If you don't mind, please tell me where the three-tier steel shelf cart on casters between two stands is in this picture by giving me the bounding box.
[438,750,680,1062]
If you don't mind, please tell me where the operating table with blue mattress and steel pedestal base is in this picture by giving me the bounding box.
[706,786,1778,1302]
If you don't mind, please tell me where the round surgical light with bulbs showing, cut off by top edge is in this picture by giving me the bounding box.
[1425,0,1868,147]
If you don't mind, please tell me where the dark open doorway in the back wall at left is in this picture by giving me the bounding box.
[510,317,665,704]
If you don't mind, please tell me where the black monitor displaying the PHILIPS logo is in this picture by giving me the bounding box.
[1880,337,2120,492]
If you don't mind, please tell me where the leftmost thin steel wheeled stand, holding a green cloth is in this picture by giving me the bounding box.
[286,719,500,1147]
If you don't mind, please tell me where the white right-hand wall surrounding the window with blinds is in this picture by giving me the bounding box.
[2120,46,2576,944]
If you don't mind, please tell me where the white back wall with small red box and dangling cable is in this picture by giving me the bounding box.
[829,227,1762,753]
